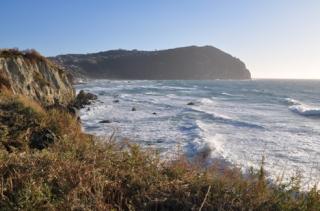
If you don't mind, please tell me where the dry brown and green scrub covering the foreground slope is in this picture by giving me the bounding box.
[0,92,320,210]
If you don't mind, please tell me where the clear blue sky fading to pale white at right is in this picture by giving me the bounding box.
[0,0,320,79]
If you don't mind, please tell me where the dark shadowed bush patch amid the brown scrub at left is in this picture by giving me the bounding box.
[29,129,58,150]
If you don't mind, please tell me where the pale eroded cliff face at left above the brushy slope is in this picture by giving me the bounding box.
[0,50,75,106]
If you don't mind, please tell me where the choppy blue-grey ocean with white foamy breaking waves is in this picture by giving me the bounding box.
[76,80,320,188]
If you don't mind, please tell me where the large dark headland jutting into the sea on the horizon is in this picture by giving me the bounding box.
[51,46,251,80]
